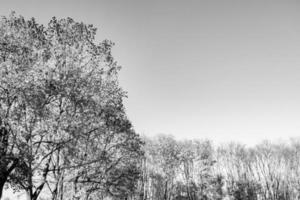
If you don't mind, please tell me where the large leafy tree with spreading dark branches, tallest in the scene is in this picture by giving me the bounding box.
[0,13,142,200]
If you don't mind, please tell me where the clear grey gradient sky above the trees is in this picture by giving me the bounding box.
[0,0,300,145]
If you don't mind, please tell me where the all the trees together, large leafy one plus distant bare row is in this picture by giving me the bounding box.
[0,13,300,200]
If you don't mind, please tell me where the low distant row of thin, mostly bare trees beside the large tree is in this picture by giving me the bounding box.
[133,135,300,200]
